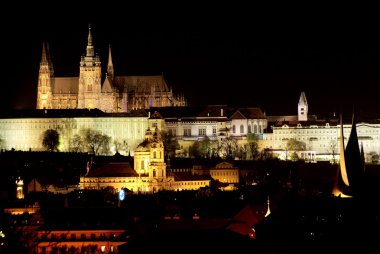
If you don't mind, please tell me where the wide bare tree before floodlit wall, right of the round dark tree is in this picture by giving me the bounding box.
[81,129,111,155]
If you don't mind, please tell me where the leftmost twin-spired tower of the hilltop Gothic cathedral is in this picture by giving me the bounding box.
[36,43,54,109]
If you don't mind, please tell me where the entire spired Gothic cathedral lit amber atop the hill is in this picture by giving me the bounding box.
[37,27,186,112]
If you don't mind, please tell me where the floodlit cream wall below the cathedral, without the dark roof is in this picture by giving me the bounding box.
[0,117,148,155]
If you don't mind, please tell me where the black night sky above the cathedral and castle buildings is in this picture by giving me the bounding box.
[0,6,380,116]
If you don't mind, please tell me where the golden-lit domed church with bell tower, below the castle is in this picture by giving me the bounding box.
[79,128,211,193]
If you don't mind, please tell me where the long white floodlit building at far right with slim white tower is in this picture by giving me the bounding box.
[262,92,380,162]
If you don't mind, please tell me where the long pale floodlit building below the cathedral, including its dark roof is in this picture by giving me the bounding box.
[0,109,148,155]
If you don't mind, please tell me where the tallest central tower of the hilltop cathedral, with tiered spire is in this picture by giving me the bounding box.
[78,26,101,108]
